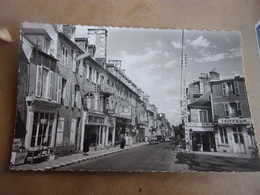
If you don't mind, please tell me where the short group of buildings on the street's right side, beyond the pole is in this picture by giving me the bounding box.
[186,69,256,155]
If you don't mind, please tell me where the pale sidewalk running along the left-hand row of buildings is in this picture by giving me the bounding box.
[10,142,149,171]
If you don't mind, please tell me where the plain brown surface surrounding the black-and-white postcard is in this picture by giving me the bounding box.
[0,0,260,194]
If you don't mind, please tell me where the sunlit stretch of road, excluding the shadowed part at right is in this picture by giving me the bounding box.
[58,142,188,171]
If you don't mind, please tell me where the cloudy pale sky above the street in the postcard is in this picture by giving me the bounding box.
[76,27,243,125]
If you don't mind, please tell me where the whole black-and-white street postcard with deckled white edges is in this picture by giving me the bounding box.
[10,22,260,172]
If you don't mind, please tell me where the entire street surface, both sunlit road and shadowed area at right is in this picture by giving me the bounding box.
[57,142,260,171]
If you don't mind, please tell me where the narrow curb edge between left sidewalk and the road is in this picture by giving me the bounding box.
[41,144,147,171]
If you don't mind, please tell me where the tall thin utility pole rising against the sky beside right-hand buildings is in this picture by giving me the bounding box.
[181,30,190,151]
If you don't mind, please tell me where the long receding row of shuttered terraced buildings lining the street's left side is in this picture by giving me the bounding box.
[14,23,172,160]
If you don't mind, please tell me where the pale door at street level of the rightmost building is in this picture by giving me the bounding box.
[233,127,245,153]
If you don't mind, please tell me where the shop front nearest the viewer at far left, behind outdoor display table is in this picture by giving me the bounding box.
[24,99,58,162]
